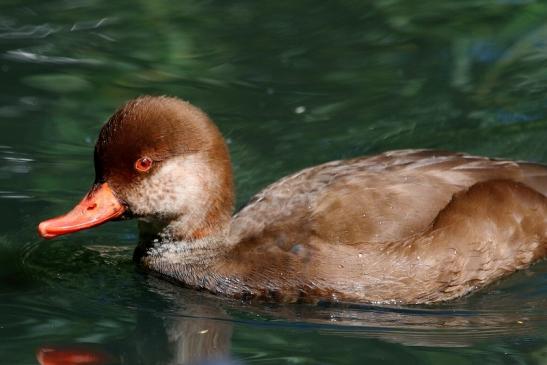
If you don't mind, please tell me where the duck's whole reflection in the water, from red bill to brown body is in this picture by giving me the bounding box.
[38,276,546,365]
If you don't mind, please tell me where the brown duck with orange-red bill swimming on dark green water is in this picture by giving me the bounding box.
[38,96,547,305]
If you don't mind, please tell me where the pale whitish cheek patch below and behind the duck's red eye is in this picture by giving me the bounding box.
[127,155,214,220]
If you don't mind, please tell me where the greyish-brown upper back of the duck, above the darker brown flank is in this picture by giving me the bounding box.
[232,150,547,249]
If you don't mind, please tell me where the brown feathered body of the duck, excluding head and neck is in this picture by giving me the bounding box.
[139,150,547,303]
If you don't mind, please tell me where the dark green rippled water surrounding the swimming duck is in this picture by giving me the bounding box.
[0,0,547,364]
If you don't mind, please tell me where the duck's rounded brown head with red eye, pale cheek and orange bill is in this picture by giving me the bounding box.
[38,96,234,240]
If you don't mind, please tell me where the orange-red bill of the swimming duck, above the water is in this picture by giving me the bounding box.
[38,183,125,238]
